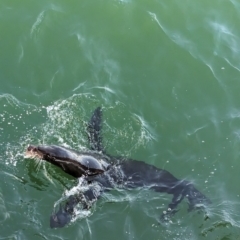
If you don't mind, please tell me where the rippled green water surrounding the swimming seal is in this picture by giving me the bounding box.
[0,0,240,240]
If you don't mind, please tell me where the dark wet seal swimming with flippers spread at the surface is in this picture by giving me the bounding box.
[26,107,211,228]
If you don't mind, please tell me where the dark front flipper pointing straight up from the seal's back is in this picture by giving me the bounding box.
[87,107,104,152]
